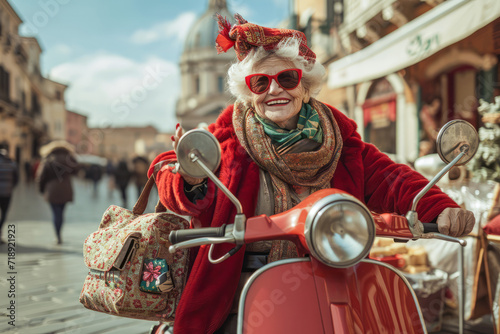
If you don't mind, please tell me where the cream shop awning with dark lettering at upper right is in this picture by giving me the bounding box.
[328,0,500,89]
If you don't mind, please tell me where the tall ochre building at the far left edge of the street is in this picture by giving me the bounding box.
[0,0,66,176]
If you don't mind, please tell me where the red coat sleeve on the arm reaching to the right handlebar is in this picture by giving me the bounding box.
[329,106,459,223]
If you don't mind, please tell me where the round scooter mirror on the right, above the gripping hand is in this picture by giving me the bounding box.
[436,119,479,166]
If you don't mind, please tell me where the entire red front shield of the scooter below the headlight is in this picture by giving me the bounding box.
[238,258,426,334]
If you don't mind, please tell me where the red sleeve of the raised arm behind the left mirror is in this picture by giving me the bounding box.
[148,151,215,217]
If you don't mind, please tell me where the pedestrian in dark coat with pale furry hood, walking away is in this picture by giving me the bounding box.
[36,140,78,245]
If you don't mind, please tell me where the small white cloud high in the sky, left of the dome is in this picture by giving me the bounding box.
[131,12,196,44]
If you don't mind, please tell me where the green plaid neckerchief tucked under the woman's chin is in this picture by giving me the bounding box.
[255,103,323,149]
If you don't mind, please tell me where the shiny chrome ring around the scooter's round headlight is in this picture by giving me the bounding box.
[304,193,375,268]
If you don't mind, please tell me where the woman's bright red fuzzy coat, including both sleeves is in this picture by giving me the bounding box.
[149,106,458,333]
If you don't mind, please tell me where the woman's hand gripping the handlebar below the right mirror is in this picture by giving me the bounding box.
[436,208,476,237]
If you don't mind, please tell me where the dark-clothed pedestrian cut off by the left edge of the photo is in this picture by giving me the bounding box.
[0,146,18,244]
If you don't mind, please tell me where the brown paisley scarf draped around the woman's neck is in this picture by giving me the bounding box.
[233,98,342,261]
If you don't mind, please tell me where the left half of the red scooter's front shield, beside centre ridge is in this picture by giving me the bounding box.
[238,258,324,334]
